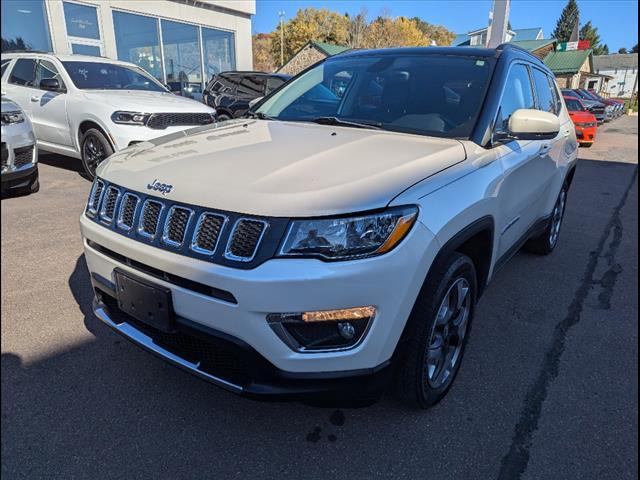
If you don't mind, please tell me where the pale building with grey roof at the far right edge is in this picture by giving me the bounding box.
[589,53,638,98]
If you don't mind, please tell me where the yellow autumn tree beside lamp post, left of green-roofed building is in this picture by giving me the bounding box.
[271,8,349,63]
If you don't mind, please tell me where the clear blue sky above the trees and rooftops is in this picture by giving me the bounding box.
[252,0,638,53]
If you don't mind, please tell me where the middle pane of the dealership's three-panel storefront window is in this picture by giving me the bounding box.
[160,20,202,84]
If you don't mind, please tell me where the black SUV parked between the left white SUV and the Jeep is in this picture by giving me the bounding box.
[202,72,291,121]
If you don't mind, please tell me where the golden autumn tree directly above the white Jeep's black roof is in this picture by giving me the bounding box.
[363,17,429,48]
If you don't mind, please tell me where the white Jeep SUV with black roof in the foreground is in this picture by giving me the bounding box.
[80,45,578,407]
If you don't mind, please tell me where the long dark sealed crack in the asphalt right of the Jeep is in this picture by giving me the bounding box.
[498,167,638,480]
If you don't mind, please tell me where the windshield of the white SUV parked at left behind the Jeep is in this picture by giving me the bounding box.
[62,62,167,92]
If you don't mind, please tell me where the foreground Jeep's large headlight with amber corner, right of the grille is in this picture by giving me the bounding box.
[280,206,418,261]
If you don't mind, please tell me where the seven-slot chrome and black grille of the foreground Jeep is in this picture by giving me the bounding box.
[86,179,288,268]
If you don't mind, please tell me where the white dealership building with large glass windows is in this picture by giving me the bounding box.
[0,0,256,88]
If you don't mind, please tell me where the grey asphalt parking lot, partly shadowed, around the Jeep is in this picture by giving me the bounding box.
[1,117,638,479]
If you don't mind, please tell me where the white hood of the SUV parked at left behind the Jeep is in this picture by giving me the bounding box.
[84,90,214,113]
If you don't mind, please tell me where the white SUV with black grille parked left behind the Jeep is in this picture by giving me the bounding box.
[2,52,215,177]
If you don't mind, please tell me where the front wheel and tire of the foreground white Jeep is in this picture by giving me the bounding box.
[396,252,477,409]
